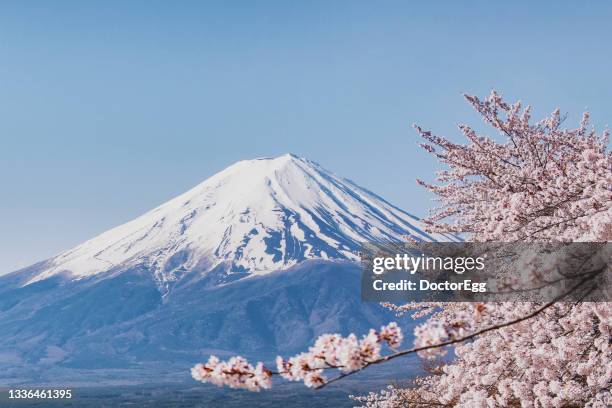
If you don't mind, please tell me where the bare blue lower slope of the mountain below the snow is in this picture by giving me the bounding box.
[0,260,411,386]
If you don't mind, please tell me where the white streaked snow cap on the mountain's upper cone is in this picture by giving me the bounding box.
[27,154,448,289]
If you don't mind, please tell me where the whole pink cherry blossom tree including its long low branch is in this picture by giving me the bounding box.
[192,92,612,408]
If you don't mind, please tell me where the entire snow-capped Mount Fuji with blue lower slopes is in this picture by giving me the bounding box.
[0,154,453,384]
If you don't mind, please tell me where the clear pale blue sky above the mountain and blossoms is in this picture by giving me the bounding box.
[0,0,612,273]
